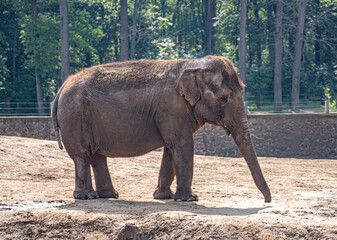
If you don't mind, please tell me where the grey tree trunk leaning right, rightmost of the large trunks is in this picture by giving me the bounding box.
[291,0,306,112]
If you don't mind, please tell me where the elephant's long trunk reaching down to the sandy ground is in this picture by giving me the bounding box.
[225,116,271,202]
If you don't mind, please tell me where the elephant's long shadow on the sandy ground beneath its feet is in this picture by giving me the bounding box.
[59,199,271,216]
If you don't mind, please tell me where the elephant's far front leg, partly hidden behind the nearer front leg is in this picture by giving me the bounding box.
[153,147,175,199]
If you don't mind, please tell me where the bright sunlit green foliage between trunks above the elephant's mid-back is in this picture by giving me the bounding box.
[136,1,203,59]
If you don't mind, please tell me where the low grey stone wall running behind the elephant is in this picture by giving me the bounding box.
[0,114,337,159]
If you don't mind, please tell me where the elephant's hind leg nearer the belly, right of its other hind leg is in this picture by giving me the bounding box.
[91,153,118,198]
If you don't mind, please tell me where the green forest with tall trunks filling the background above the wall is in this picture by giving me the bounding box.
[0,0,337,115]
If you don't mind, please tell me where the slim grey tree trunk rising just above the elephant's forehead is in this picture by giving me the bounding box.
[239,0,247,94]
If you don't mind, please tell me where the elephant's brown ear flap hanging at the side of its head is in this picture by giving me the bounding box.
[176,68,201,107]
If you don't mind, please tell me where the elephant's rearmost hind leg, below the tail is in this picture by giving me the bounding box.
[74,156,98,200]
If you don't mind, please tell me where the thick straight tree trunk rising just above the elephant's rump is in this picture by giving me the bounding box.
[60,0,70,82]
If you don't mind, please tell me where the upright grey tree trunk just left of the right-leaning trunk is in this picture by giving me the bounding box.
[274,0,283,112]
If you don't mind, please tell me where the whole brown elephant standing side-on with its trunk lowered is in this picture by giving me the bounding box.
[52,56,271,202]
